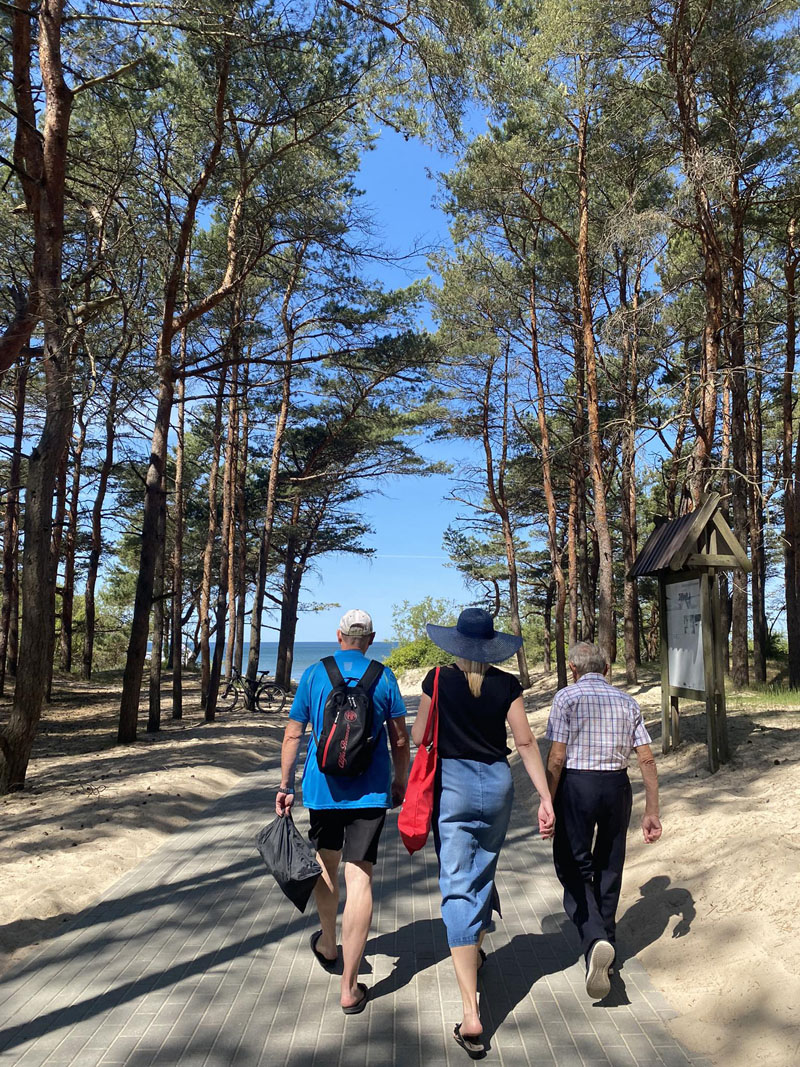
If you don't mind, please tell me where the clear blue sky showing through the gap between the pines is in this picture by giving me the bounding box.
[285,130,480,641]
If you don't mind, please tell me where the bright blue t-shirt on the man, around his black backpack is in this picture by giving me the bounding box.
[289,649,405,811]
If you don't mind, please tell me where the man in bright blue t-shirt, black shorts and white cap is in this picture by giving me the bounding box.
[275,608,409,1015]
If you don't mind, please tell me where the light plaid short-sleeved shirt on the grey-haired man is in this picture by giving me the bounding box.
[545,674,651,770]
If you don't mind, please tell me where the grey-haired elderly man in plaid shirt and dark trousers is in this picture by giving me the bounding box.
[545,641,661,1000]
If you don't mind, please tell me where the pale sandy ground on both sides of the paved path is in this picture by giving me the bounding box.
[0,673,800,1067]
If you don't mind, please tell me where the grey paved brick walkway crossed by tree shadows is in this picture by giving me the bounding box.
[0,721,704,1067]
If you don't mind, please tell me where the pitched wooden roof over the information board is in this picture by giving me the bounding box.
[628,493,752,578]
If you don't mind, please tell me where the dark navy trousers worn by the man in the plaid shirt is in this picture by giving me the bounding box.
[553,770,631,955]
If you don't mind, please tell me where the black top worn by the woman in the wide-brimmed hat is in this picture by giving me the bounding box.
[422,664,523,763]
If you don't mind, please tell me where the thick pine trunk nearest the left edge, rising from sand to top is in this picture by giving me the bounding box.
[0,0,73,794]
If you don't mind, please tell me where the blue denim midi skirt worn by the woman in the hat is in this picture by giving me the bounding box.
[434,760,514,947]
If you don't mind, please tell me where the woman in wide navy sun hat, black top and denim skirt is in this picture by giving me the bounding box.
[412,608,555,1058]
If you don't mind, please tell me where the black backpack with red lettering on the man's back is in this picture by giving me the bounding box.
[314,656,383,778]
